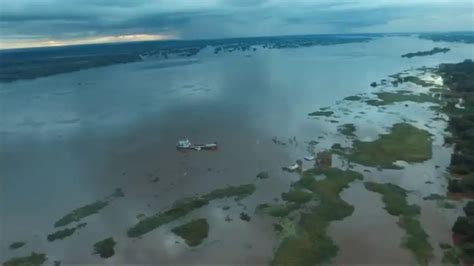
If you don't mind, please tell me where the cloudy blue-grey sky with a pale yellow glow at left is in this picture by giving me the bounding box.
[0,0,474,48]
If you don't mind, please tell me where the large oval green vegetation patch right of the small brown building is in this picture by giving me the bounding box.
[333,123,432,169]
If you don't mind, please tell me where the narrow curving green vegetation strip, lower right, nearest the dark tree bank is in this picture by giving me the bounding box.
[364,182,433,265]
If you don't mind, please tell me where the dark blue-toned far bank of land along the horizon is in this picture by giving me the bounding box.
[0,35,371,82]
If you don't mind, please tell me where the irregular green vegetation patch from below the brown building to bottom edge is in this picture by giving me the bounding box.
[272,168,363,265]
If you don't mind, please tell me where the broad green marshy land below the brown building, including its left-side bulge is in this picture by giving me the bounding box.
[256,168,363,265]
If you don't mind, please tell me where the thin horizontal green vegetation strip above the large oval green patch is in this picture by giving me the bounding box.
[365,91,439,106]
